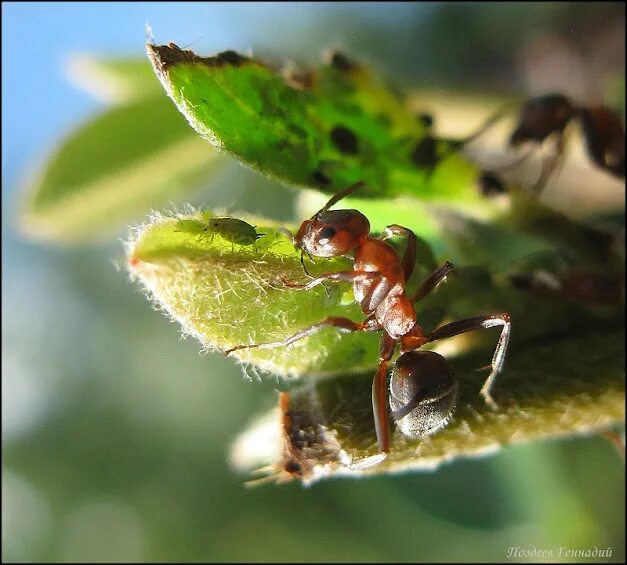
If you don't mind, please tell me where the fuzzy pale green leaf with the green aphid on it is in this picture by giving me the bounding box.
[128,214,378,377]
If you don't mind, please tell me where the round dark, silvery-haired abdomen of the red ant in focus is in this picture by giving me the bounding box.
[390,351,457,437]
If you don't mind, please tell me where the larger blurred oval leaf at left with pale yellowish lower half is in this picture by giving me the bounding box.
[21,96,226,242]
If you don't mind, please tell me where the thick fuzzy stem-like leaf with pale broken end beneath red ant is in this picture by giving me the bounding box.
[232,328,625,484]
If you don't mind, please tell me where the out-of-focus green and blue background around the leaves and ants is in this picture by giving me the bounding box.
[2,2,625,562]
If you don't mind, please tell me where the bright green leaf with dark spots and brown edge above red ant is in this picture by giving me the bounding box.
[147,43,494,216]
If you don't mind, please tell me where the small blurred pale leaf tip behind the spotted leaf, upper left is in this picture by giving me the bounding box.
[66,54,161,103]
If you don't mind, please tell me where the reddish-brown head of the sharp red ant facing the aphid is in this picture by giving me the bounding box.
[294,210,370,257]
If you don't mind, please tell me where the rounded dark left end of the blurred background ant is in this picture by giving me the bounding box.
[509,94,575,146]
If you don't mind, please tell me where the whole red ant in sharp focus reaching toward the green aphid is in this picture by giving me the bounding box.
[224,181,511,454]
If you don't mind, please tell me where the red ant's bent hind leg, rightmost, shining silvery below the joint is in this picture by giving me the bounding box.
[425,312,512,409]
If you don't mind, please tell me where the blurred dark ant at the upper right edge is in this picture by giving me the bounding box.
[474,94,625,195]
